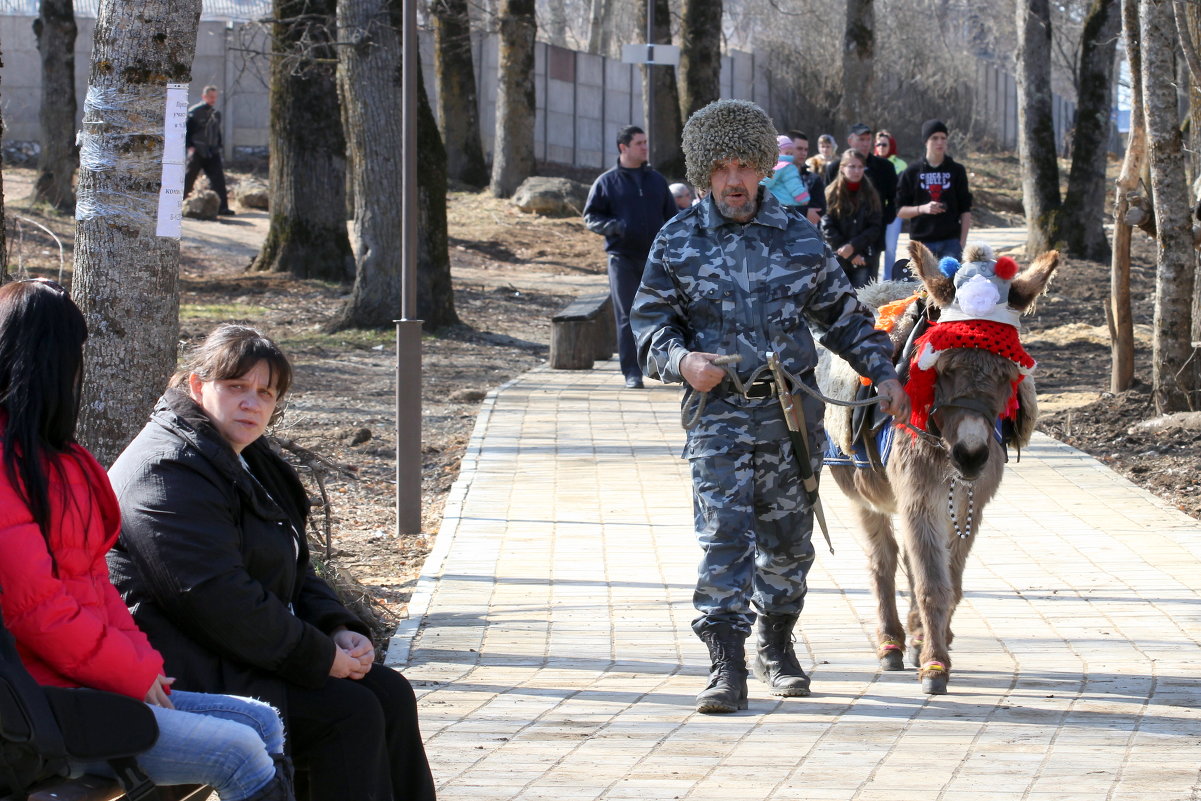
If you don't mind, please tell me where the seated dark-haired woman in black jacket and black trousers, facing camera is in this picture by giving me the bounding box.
[109,325,435,801]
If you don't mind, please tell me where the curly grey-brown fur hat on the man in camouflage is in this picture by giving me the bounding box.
[681,100,779,190]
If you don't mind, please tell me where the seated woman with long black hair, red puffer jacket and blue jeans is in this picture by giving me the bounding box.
[0,279,294,801]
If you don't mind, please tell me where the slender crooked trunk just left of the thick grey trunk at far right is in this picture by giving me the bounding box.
[1106,0,1147,393]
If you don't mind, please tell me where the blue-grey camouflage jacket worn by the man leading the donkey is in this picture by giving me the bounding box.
[631,190,897,400]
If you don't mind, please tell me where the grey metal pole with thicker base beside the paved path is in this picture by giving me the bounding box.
[396,0,422,542]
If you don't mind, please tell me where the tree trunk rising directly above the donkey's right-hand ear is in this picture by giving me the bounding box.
[1017,0,1059,259]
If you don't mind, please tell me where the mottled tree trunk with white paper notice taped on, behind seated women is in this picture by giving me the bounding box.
[72,0,201,465]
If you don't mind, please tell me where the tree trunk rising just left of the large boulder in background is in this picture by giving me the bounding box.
[490,0,538,197]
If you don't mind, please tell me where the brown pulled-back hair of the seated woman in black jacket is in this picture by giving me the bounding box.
[171,323,292,423]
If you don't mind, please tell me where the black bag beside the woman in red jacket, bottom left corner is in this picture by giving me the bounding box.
[0,621,159,801]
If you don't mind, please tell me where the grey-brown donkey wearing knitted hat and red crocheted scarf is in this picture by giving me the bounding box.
[821,243,1059,694]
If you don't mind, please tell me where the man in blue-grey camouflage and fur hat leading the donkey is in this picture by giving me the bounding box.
[632,100,908,712]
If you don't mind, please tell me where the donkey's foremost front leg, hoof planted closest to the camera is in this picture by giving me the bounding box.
[903,500,952,694]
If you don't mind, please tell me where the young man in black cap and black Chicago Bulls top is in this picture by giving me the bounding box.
[897,120,972,258]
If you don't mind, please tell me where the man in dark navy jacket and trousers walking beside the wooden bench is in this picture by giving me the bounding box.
[584,125,677,389]
